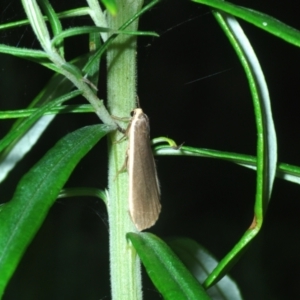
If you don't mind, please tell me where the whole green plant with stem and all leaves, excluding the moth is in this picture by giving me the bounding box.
[0,0,300,300]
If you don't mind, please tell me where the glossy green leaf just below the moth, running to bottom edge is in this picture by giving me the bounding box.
[127,233,210,300]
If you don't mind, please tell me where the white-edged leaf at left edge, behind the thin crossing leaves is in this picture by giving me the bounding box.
[0,55,95,182]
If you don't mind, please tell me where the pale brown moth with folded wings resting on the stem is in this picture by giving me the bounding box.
[126,108,161,231]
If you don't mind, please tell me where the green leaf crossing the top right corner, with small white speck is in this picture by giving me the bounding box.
[192,0,300,47]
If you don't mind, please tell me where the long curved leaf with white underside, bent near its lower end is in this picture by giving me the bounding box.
[199,12,277,288]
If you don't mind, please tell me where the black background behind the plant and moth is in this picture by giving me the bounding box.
[0,0,300,300]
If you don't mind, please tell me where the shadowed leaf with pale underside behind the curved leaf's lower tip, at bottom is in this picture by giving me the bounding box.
[167,238,242,300]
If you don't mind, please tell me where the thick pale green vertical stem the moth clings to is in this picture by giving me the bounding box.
[107,0,143,300]
